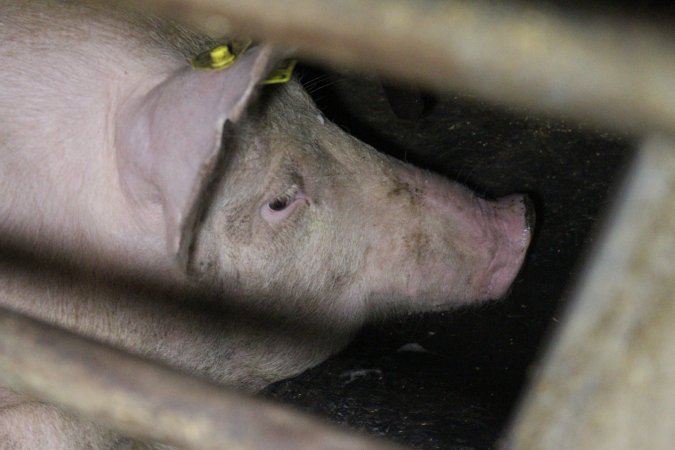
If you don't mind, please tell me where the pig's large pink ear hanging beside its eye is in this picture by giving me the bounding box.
[115,47,277,261]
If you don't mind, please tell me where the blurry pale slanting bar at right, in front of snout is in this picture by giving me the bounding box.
[506,138,675,450]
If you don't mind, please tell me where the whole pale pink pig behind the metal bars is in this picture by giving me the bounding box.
[0,0,532,449]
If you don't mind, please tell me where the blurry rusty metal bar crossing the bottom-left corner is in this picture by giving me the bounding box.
[0,308,401,450]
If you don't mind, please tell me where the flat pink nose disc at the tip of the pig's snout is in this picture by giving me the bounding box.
[477,194,535,299]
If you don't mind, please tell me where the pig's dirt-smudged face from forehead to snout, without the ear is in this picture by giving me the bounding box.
[191,83,530,322]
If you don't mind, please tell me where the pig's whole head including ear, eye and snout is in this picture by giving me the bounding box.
[118,46,530,330]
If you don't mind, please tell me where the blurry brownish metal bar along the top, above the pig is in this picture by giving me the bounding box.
[118,0,675,132]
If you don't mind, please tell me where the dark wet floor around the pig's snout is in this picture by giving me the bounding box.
[266,68,635,449]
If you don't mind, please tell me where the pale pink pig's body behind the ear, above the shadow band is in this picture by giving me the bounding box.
[0,0,207,270]
